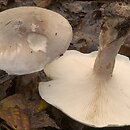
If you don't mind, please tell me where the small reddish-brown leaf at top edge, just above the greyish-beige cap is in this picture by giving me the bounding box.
[33,0,52,8]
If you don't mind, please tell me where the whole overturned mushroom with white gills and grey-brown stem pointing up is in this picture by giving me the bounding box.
[39,3,130,127]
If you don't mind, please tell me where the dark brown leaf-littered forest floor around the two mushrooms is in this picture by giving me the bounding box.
[0,0,130,130]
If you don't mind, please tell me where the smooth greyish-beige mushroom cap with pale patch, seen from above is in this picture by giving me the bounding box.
[0,7,72,74]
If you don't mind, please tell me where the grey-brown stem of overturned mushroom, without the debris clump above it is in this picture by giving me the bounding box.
[94,17,130,79]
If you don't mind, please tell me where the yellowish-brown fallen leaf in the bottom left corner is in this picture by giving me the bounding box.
[0,94,30,130]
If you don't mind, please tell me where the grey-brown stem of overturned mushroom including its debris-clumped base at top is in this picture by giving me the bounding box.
[93,2,130,79]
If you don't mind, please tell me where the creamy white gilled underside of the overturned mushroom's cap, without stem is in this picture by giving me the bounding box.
[39,51,130,127]
